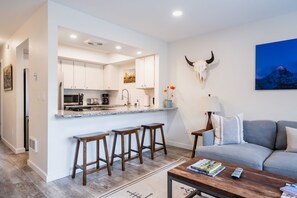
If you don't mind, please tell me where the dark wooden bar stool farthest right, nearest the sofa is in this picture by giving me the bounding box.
[141,123,167,160]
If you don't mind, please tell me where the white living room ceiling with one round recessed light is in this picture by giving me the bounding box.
[0,0,297,45]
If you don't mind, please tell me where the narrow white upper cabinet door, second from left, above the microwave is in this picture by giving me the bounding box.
[73,62,86,89]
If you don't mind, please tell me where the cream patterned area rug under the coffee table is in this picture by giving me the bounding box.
[99,159,208,198]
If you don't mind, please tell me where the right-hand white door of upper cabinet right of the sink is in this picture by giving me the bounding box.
[144,56,155,88]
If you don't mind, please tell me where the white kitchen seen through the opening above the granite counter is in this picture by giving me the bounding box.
[58,28,159,115]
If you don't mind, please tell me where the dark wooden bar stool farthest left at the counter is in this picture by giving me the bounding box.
[72,132,111,185]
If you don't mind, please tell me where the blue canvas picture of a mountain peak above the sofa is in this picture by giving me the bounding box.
[256,39,297,90]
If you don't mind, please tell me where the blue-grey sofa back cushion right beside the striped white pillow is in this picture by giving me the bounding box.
[243,120,276,149]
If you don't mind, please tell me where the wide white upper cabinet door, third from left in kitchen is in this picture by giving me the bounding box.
[86,63,103,90]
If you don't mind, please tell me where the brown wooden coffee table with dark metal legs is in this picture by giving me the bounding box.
[167,157,297,198]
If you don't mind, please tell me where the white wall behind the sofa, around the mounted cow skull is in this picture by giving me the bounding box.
[169,13,297,148]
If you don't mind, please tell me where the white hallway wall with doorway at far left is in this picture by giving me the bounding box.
[1,2,48,166]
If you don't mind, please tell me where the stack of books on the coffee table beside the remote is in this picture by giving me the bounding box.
[187,159,226,177]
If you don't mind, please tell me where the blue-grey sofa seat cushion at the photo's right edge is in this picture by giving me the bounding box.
[264,150,297,178]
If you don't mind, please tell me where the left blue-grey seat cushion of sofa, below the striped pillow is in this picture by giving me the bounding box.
[196,143,272,170]
